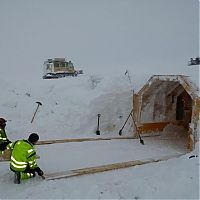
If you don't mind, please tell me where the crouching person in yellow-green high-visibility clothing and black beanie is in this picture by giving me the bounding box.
[10,133,44,184]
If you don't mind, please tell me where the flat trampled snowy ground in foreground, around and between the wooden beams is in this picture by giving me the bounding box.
[0,137,199,199]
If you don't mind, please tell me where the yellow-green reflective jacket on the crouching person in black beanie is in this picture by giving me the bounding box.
[10,140,38,172]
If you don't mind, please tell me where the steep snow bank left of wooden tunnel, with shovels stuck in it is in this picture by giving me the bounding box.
[0,72,135,139]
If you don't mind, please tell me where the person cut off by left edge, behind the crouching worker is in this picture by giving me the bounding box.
[0,118,11,156]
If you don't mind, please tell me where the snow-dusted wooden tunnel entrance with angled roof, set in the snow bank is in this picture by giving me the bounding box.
[133,75,200,150]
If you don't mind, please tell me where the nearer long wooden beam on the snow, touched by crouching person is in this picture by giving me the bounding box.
[44,154,185,181]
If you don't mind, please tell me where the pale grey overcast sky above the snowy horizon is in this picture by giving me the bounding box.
[0,0,199,82]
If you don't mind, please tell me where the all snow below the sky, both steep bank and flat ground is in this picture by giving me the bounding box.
[0,67,199,199]
